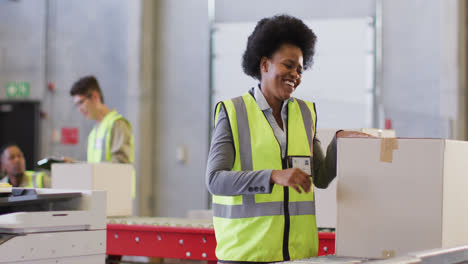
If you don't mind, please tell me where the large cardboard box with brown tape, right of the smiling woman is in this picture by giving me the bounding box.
[335,138,468,258]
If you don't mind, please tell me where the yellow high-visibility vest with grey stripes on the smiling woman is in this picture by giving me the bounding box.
[213,93,318,262]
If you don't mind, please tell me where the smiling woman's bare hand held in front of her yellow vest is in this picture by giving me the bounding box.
[270,168,312,193]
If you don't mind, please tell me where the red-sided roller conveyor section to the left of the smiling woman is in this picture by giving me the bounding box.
[107,217,217,263]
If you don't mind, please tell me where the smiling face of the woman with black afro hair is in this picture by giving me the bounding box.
[260,44,303,104]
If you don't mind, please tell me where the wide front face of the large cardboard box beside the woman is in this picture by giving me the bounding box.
[336,138,444,258]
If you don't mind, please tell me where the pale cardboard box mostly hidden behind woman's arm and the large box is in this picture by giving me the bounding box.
[314,128,395,228]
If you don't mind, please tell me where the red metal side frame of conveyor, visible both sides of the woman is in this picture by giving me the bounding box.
[107,224,335,263]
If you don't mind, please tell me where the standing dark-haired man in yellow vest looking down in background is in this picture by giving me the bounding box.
[70,76,133,163]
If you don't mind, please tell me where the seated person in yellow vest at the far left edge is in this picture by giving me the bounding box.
[0,144,51,188]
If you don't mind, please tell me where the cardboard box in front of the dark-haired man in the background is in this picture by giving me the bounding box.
[51,163,133,216]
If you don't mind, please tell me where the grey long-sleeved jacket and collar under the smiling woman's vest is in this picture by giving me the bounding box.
[206,87,336,195]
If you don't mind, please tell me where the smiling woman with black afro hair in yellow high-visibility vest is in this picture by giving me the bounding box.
[206,15,372,263]
